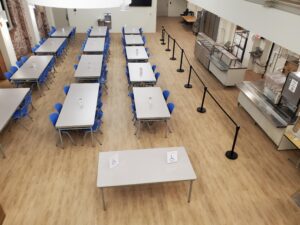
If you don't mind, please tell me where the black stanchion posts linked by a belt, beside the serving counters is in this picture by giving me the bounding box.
[160,26,240,160]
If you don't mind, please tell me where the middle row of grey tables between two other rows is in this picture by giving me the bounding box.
[55,27,107,147]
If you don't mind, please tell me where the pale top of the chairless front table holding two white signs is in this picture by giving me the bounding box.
[97,147,197,188]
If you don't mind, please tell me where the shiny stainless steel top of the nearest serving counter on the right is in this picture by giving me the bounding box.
[237,81,289,128]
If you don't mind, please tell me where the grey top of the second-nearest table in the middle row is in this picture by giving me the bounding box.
[74,55,103,79]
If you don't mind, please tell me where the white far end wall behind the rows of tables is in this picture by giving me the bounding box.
[68,0,157,33]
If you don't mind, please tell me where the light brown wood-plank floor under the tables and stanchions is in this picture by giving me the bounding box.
[0,18,300,225]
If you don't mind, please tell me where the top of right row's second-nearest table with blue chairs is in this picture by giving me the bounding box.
[128,62,156,83]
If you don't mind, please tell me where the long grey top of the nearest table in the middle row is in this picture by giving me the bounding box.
[56,83,99,129]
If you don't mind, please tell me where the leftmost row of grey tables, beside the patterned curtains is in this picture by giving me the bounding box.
[0,27,75,156]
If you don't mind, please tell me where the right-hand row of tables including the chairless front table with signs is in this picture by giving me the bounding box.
[97,27,197,210]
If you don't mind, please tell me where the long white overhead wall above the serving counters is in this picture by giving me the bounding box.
[189,0,300,54]
